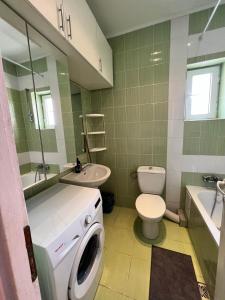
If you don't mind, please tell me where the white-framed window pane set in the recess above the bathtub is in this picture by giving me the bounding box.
[186,66,220,120]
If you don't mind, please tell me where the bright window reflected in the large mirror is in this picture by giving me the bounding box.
[31,90,55,129]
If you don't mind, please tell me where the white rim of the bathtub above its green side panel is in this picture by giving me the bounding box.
[186,185,220,247]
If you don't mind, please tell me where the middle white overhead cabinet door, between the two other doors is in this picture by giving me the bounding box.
[63,0,98,69]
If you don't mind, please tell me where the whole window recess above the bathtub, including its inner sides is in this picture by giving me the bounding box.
[185,53,225,121]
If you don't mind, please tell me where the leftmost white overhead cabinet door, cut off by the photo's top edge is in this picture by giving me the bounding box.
[29,0,65,33]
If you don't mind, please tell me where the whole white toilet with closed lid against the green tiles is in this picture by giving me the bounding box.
[135,166,166,239]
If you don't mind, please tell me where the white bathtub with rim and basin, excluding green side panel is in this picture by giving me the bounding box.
[185,185,223,246]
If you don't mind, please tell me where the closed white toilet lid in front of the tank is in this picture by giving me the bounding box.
[135,194,166,219]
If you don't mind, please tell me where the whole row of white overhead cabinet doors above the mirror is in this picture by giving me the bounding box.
[26,0,113,87]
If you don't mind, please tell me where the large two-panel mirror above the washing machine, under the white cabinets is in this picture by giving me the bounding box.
[0,3,67,191]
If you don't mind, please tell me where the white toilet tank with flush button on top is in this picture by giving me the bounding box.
[137,166,166,195]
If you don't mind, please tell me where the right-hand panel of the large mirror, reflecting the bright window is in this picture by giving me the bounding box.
[28,25,71,179]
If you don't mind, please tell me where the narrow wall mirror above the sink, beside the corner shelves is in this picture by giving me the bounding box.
[70,81,85,156]
